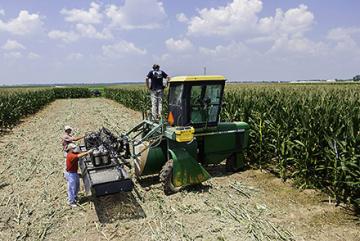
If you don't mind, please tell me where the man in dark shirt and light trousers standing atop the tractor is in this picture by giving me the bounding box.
[145,64,170,119]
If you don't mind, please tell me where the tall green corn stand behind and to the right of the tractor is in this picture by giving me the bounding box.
[105,84,360,209]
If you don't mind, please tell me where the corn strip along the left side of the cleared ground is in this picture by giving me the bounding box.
[0,88,91,130]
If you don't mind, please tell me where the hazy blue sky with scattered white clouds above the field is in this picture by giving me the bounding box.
[0,0,360,85]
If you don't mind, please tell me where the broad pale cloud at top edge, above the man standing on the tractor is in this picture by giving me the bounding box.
[106,0,166,29]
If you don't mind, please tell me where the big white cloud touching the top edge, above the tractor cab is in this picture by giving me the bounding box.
[188,0,262,35]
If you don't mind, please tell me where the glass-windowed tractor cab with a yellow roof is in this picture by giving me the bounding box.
[168,75,225,128]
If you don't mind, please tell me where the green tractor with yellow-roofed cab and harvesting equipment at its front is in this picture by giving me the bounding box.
[85,76,249,194]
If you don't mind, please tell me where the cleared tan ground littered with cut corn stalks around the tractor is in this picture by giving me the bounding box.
[0,98,360,240]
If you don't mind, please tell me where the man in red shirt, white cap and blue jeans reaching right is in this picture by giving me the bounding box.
[65,143,92,207]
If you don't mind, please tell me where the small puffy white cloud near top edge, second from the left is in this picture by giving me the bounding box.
[60,2,103,24]
